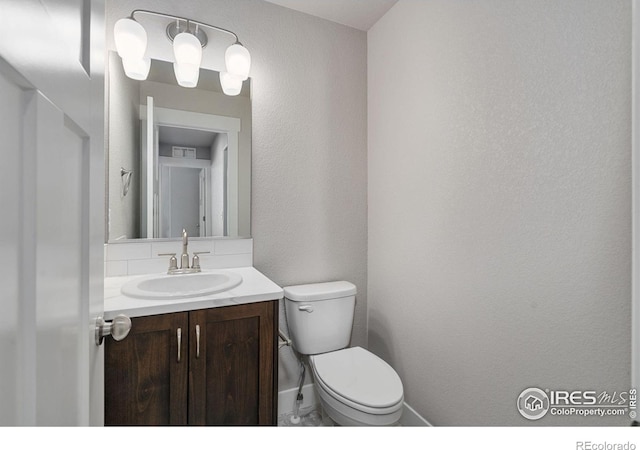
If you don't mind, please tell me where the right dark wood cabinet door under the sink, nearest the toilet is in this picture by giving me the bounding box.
[189,301,278,425]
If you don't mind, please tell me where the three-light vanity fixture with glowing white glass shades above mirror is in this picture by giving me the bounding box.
[114,9,251,95]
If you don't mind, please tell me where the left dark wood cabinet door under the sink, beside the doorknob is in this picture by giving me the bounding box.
[104,312,189,425]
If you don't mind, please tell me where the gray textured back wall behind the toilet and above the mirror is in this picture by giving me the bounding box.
[107,0,367,389]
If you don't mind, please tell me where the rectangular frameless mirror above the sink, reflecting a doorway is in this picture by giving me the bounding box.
[106,53,251,242]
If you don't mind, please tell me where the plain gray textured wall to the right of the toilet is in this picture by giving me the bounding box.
[368,0,631,425]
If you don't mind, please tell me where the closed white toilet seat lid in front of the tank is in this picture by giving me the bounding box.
[309,347,404,415]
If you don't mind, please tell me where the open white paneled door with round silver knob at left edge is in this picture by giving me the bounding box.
[0,0,104,426]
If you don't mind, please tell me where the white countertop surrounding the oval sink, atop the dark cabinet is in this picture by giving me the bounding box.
[104,267,284,320]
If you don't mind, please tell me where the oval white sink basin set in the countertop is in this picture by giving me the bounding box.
[121,272,242,300]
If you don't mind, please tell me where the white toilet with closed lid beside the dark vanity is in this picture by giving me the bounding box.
[284,281,404,426]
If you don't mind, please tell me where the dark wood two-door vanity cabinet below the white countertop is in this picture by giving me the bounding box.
[105,300,278,425]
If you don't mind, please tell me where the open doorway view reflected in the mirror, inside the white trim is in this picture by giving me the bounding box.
[158,126,227,238]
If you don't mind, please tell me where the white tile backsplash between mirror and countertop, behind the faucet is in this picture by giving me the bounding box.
[104,239,253,277]
